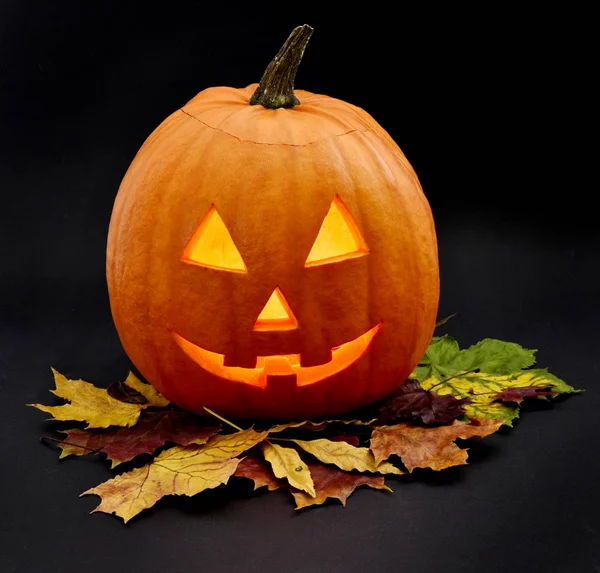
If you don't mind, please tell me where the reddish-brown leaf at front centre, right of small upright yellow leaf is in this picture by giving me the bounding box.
[291,464,392,509]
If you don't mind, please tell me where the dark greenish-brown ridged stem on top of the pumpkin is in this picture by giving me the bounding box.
[250,24,313,109]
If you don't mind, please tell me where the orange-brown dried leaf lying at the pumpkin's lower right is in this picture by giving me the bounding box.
[371,420,502,472]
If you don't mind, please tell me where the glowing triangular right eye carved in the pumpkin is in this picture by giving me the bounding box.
[304,195,369,267]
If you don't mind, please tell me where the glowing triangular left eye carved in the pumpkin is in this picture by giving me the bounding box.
[181,205,248,273]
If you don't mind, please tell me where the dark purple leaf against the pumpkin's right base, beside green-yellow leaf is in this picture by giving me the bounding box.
[378,379,470,424]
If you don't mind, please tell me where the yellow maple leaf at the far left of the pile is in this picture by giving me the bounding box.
[28,368,144,428]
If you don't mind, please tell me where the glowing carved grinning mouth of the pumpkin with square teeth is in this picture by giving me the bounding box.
[172,323,381,388]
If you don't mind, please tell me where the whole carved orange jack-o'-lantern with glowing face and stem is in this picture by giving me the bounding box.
[107,26,439,418]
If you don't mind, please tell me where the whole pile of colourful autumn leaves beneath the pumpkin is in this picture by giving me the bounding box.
[32,336,577,522]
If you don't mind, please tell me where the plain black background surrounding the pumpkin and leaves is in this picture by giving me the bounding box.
[0,0,600,573]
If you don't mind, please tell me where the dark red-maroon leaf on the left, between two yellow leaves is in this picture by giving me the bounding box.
[58,411,219,468]
